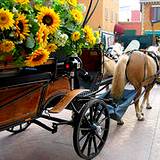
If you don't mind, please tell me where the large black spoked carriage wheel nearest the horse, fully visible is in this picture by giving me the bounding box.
[73,99,110,159]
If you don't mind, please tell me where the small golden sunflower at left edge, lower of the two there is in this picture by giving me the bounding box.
[0,40,15,53]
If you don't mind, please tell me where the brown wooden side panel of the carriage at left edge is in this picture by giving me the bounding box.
[0,84,42,126]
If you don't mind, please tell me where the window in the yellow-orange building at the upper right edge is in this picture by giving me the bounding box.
[151,6,160,21]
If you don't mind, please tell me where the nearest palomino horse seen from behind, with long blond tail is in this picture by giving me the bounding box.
[111,51,158,120]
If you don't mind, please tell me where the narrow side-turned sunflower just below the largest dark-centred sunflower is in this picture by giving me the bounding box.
[37,24,49,47]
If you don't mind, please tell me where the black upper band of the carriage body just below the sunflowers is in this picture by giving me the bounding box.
[0,72,52,88]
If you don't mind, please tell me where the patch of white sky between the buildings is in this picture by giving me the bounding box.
[119,0,140,21]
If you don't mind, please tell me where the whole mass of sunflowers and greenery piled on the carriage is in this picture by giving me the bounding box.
[0,0,99,67]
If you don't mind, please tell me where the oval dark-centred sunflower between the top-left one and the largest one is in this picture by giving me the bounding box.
[15,14,30,40]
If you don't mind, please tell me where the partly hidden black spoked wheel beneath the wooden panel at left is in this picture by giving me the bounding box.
[7,122,31,133]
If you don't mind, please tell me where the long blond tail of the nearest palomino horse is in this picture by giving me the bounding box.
[111,55,129,100]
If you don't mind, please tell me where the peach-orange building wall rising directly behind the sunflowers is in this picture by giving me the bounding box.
[79,0,119,33]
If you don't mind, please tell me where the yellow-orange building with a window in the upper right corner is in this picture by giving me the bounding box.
[140,0,160,36]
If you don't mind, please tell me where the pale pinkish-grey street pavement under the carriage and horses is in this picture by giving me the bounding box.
[0,85,160,160]
